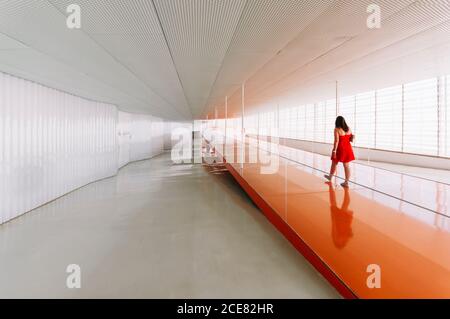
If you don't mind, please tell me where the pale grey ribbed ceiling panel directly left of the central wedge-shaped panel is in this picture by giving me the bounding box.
[49,0,192,118]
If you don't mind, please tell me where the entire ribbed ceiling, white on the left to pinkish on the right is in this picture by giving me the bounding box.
[0,0,450,120]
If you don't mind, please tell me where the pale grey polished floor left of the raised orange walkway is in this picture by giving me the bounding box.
[0,154,339,298]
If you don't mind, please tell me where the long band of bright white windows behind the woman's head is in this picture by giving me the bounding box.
[251,76,450,157]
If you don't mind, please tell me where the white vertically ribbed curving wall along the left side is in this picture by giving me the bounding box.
[0,72,163,224]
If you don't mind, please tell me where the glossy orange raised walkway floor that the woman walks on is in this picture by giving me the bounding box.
[214,140,450,298]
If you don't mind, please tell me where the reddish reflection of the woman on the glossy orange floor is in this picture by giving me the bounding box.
[328,183,353,249]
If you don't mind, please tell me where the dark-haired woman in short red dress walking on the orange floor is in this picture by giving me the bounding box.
[325,116,355,188]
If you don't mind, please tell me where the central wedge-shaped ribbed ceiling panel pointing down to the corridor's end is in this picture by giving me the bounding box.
[154,0,246,116]
